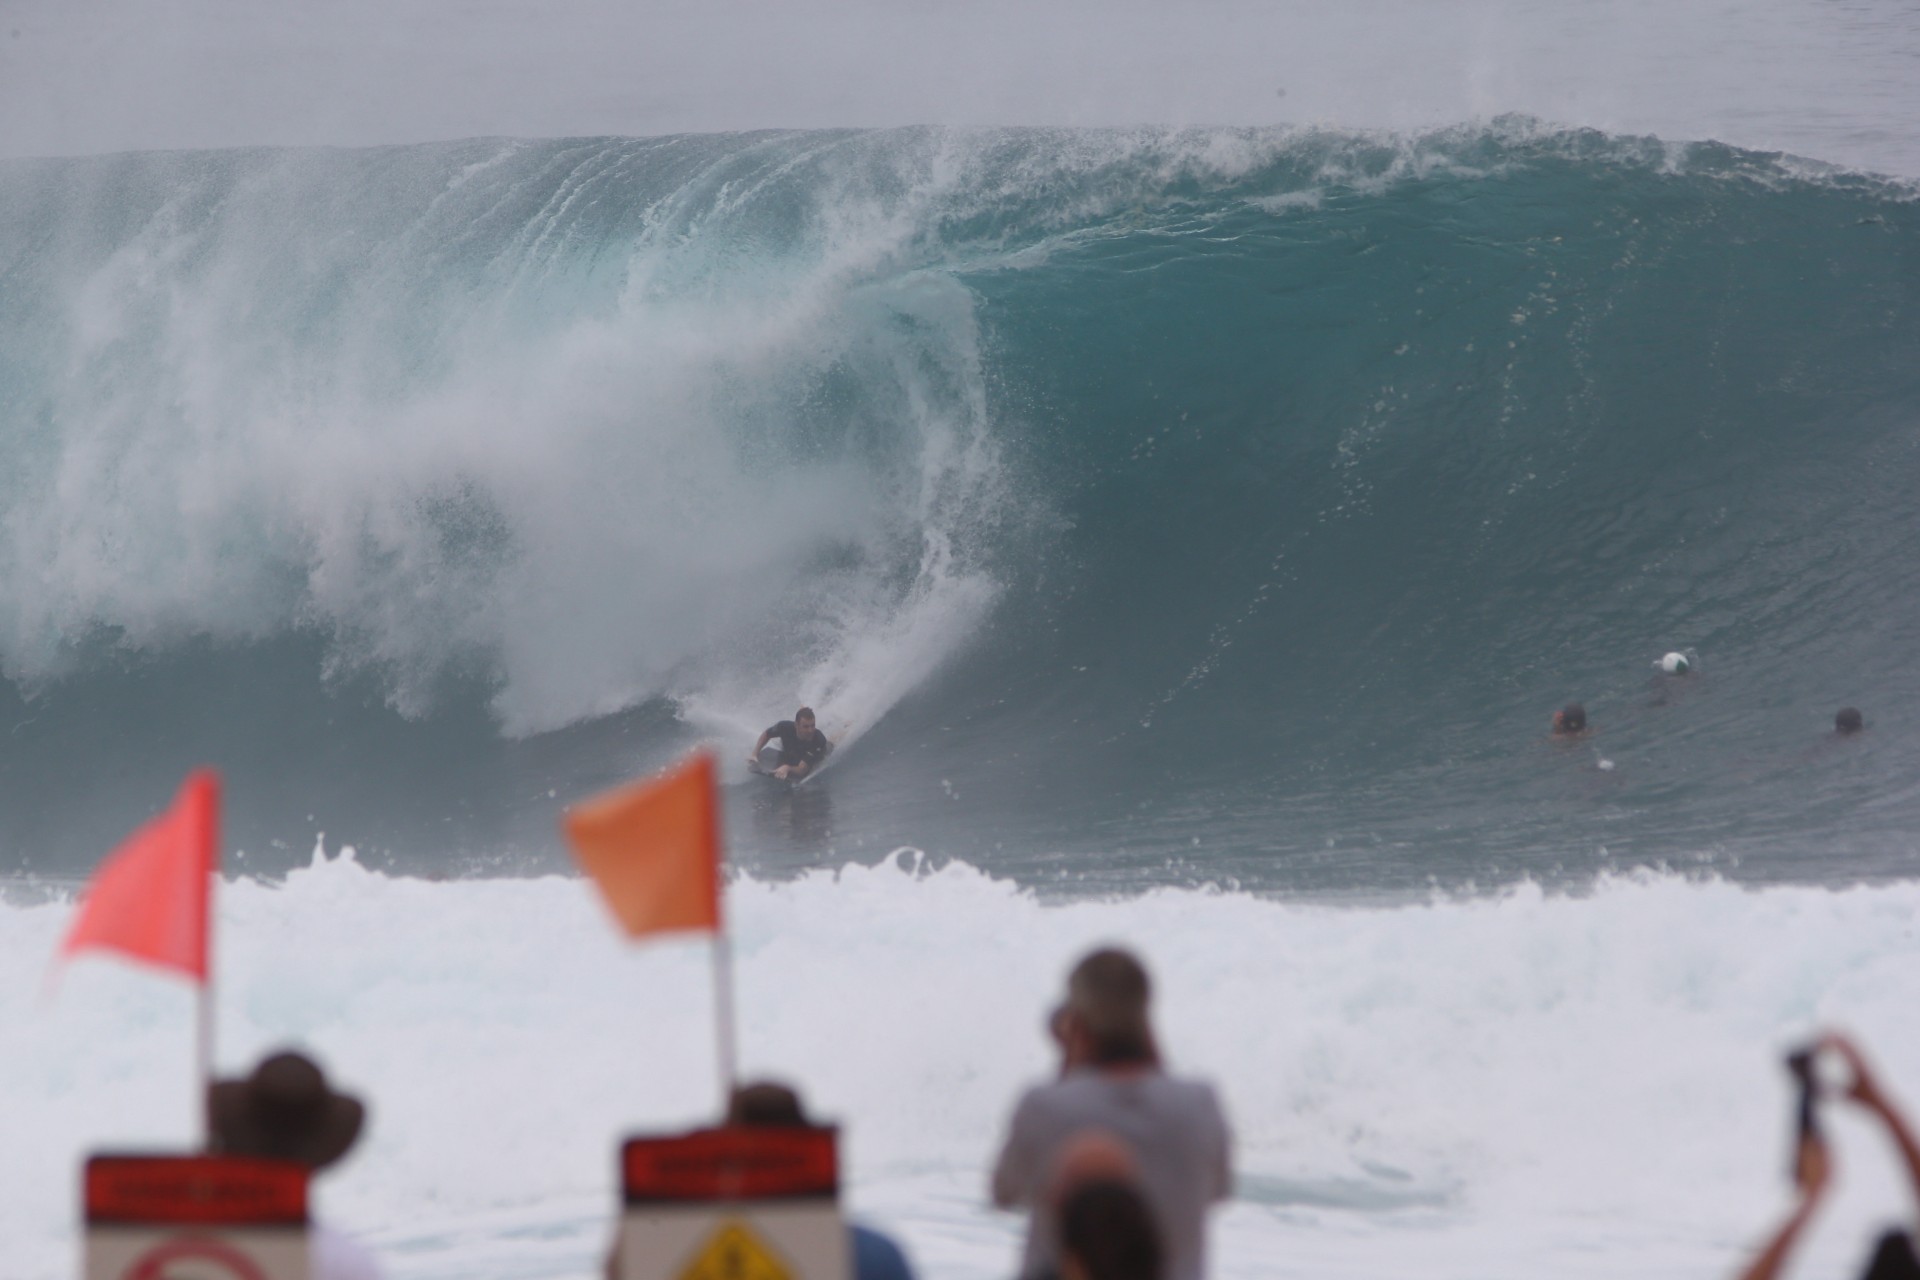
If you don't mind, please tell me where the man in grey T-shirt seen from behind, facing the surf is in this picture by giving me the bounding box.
[993,948,1233,1280]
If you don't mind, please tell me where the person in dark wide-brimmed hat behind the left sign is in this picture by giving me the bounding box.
[207,1052,380,1280]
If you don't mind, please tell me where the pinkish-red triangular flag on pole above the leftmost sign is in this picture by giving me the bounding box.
[60,770,221,983]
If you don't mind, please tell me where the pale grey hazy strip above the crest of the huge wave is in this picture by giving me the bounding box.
[0,0,1920,175]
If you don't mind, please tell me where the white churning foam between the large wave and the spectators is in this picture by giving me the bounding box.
[0,858,1920,1280]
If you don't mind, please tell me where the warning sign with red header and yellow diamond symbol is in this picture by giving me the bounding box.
[614,1126,852,1280]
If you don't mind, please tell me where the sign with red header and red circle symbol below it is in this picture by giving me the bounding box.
[83,1155,309,1280]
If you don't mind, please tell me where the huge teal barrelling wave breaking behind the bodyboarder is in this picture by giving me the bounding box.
[0,119,1920,889]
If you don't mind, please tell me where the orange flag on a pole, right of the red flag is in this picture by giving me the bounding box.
[564,750,720,938]
